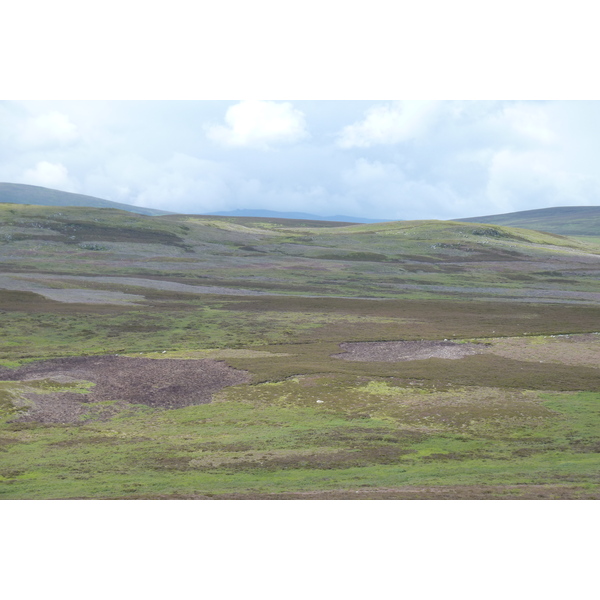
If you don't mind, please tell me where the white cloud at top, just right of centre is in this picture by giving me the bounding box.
[337,100,439,148]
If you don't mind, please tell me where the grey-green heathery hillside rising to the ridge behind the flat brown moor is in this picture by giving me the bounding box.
[0,204,600,300]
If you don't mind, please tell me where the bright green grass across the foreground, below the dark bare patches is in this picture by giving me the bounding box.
[0,382,600,498]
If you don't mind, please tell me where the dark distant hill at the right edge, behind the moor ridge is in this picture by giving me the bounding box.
[452,206,600,236]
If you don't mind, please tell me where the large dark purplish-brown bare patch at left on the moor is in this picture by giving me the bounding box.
[0,356,250,423]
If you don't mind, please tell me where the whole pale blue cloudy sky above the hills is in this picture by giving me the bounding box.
[0,99,600,219]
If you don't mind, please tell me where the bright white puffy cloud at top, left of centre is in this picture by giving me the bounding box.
[205,100,308,149]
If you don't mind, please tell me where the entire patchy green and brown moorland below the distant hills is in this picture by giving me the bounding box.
[0,204,600,499]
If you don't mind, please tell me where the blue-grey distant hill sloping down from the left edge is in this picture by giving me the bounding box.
[0,183,173,216]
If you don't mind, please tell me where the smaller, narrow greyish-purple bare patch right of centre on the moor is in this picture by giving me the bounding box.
[332,341,485,362]
